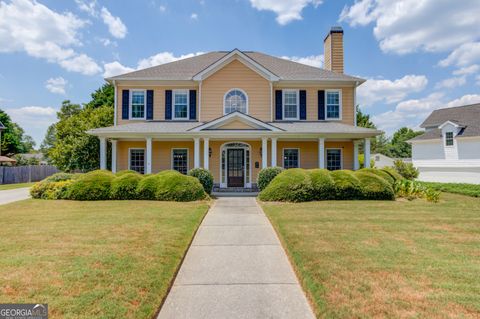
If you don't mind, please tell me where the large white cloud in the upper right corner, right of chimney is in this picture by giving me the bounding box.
[340,0,480,54]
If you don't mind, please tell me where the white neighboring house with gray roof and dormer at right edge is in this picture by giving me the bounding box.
[410,104,480,184]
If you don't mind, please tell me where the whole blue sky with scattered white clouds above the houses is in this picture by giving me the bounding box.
[0,0,480,144]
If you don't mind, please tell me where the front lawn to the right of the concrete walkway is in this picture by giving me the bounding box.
[261,193,480,318]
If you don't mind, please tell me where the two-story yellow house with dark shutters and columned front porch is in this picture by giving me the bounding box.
[89,27,380,188]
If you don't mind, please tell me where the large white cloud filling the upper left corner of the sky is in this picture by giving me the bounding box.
[0,0,100,75]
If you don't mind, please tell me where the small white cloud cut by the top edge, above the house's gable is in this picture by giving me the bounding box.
[250,0,323,25]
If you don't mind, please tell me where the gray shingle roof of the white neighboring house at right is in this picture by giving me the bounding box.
[412,104,480,141]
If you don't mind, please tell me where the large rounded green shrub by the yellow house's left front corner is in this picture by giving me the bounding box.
[67,170,115,200]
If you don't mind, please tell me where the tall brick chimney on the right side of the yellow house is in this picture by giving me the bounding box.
[323,27,343,73]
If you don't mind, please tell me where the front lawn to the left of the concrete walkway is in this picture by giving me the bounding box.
[0,199,208,318]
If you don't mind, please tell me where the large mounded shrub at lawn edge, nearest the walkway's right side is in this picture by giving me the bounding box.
[259,168,313,202]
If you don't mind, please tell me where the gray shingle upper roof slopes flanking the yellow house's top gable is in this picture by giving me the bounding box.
[108,51,364,82]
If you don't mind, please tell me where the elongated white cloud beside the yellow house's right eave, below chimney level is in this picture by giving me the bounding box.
[357,75,428,106]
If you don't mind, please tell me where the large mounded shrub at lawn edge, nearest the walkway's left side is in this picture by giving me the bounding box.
[155,171,206,202]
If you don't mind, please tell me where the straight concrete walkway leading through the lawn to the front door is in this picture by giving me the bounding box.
[158,197,315,319]
